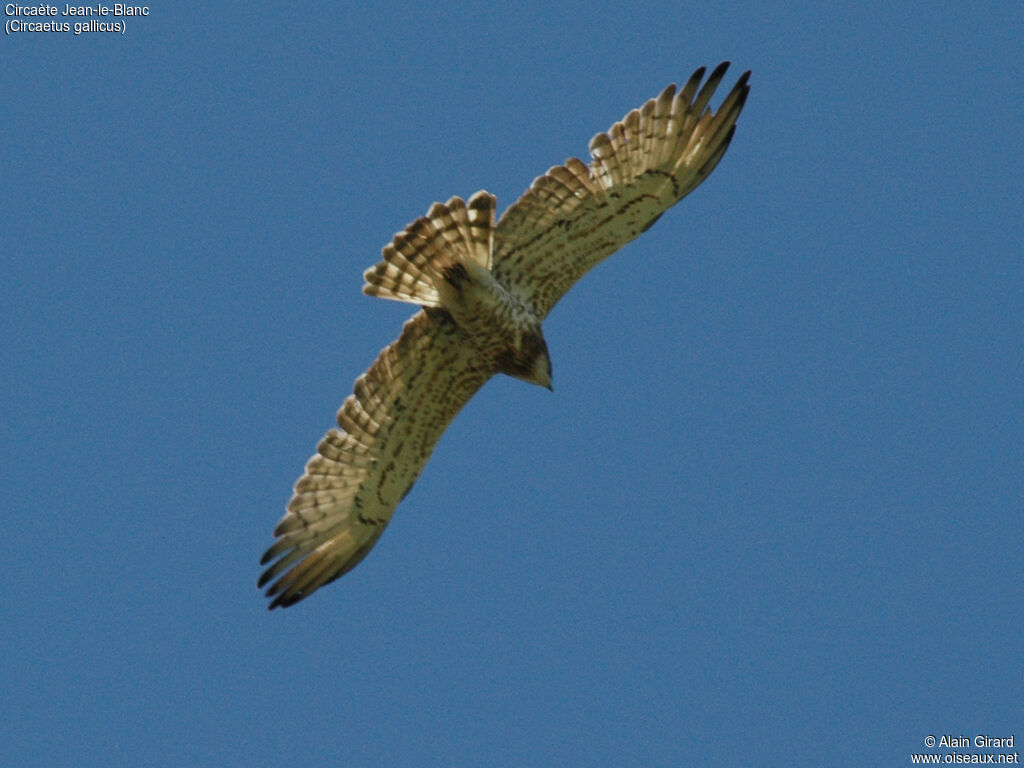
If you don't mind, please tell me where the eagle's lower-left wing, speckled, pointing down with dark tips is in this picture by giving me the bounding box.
[259,309,492,608]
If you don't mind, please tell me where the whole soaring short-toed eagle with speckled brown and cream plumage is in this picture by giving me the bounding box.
[258,61,750,608]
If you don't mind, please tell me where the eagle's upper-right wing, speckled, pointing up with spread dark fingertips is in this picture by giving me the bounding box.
[492,61,750,317]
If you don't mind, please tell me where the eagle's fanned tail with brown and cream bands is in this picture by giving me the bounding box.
[362,191,495,307]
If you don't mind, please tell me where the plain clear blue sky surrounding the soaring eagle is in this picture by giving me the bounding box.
[0,0,1024,768]
